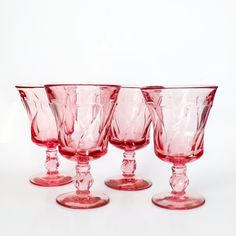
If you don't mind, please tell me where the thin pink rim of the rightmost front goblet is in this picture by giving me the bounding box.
[141,85,218,90]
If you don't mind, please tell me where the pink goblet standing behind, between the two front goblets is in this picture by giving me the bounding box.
[105,87,151,191]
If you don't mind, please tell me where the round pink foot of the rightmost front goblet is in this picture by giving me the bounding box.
[152,193,205,210]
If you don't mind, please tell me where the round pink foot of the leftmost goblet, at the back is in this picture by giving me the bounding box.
[30,173,72,187]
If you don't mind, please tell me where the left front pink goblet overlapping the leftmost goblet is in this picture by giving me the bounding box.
[45,85,120,209]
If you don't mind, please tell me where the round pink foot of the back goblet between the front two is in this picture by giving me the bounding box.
[105,177,152,191]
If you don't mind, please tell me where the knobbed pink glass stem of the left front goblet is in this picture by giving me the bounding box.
[74,162,93,195]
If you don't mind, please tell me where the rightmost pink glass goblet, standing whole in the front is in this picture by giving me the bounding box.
[142,86,217,209]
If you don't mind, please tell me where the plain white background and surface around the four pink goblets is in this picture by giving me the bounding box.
[0,0,236,236]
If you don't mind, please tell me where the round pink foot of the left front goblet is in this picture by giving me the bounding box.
[57,192,109,209]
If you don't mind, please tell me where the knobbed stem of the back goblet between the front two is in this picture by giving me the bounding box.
[121,151,136,178]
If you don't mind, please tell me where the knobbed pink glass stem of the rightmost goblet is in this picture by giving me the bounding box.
[170,165,189,195]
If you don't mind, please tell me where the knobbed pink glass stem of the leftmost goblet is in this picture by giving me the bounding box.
[44,148,59,175]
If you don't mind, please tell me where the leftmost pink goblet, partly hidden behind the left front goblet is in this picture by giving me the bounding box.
[16,86,72,187]
